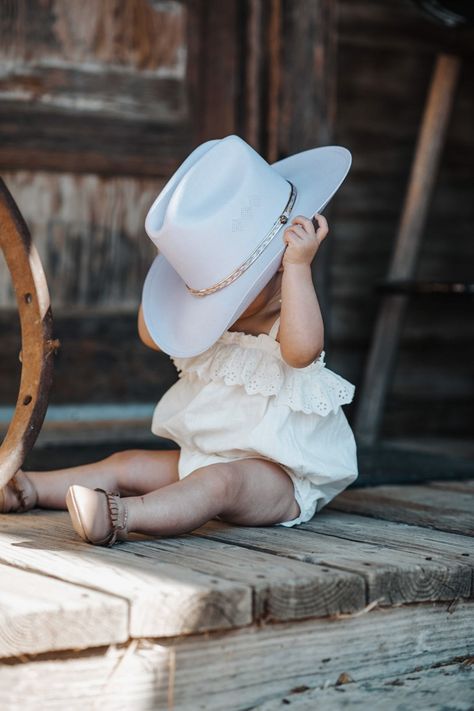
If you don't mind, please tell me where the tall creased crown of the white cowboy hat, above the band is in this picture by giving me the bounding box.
[145,135,290,290]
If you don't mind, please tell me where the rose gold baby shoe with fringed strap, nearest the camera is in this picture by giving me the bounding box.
[66,484,128,547]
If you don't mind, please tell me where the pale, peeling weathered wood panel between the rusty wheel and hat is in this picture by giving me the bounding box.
[0,172,163,310]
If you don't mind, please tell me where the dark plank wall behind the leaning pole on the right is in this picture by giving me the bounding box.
[329,0,474,437]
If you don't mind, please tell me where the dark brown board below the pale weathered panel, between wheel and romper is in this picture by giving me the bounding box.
[0,308,178,405]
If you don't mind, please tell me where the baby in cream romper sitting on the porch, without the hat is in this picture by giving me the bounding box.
[0,214,357,546]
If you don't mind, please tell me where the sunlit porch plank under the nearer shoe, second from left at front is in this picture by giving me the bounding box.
[0,510,252,637]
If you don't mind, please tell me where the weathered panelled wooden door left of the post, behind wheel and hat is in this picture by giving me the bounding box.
[0,0,241,414]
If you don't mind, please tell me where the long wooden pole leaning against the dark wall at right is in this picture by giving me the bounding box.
[354,54,461,446]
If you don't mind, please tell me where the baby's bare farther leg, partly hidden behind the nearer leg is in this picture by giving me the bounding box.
[25,449,179,509]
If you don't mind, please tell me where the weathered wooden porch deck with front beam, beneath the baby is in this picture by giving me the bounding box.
[0,480,474,711]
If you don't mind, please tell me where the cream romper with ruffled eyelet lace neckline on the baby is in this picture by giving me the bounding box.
[151,317,358,526]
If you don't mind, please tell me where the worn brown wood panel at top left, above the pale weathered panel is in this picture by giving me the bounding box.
[0,0,195,175]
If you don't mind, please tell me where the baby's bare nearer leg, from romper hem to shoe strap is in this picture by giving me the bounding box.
[126,458,300,536]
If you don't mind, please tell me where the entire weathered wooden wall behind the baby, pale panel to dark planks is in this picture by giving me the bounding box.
[0,0,474,444]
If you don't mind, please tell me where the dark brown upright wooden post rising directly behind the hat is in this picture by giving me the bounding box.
[243,0,337,340]
